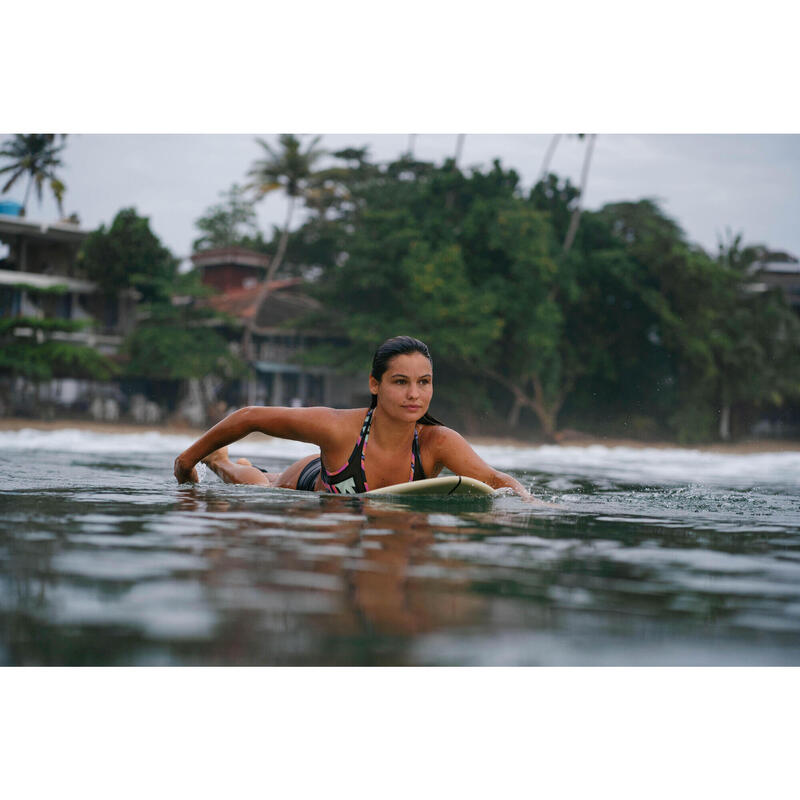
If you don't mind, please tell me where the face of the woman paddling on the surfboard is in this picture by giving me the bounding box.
[369,353,433,422]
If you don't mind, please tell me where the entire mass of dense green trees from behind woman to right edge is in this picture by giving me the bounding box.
[296,151,800,442]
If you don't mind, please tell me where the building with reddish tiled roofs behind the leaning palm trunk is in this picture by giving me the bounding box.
[192,247,368,407]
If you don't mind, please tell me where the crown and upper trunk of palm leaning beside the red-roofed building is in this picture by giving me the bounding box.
[247,133,325,284]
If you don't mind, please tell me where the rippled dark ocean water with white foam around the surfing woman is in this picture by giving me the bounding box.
[0,430,800,666]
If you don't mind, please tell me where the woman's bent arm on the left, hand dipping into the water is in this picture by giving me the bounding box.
[175,406,340,483]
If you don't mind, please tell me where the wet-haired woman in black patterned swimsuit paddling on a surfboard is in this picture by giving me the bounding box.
[175,336,533,500]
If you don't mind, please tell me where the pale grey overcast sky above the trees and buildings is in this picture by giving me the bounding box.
[2,134,800,264]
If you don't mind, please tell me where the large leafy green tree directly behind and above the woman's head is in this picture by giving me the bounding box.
[300,158,588,437]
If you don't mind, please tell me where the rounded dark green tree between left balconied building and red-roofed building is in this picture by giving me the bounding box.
[78,208,178,303]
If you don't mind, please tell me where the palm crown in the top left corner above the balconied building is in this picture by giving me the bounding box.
[0,133,66,215]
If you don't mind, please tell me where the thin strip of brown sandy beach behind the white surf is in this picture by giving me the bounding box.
[0,417,800,455]
